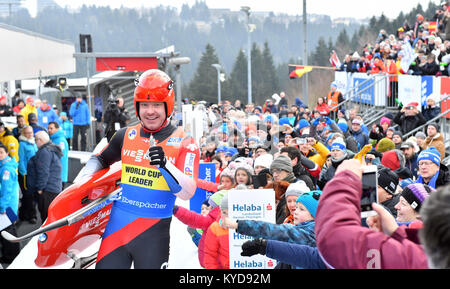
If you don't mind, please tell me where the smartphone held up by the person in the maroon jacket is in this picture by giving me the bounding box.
[361,165,378,218]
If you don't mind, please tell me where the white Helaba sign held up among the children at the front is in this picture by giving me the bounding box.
[228,189,276,269]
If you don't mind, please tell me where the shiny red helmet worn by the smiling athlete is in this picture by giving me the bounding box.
[134,69,175,125]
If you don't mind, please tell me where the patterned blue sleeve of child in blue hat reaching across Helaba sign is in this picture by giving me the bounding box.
[236,220,316,247]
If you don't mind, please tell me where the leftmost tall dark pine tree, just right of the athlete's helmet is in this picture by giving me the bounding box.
[189,43,219,103]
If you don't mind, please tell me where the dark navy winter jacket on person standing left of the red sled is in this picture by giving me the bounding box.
[27,142,63,194]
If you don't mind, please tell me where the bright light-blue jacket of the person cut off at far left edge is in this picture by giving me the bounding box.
[0,156,19,215]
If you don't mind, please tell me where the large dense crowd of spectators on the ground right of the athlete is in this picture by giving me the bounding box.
[168,76,450,269]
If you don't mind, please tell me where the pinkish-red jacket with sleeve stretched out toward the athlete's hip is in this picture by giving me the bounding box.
[174,206,220,268]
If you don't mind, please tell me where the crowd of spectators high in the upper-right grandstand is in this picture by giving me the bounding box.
[335,1,450,76]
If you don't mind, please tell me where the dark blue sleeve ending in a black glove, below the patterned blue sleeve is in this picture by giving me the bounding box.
[266,240,327,269]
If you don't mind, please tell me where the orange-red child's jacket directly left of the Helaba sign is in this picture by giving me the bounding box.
[204,221,230,269]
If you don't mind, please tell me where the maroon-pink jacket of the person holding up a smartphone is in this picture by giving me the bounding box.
[315,171,428,269]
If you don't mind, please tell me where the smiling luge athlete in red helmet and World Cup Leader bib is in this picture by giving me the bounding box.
[78,69,200,269]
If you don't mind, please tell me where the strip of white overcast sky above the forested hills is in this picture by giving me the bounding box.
[40,0,442,18]
